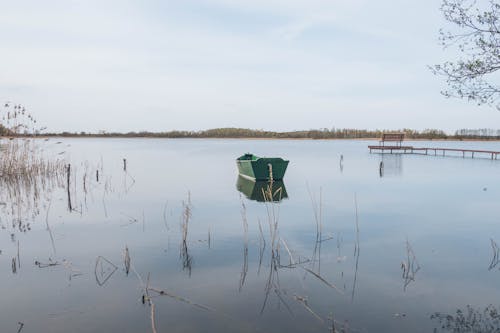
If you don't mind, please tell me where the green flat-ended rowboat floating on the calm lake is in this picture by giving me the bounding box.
[236,153,289,180]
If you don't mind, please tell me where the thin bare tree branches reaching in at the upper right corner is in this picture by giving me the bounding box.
[430,0,500,110]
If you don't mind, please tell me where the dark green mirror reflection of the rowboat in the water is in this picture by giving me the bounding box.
[236,176,288,202]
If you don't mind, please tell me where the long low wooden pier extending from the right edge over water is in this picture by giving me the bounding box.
[368,145,500,160]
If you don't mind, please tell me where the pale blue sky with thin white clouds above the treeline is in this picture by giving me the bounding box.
[0,0,500,132]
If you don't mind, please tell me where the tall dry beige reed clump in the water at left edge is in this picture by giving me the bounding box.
[0,102,65,231]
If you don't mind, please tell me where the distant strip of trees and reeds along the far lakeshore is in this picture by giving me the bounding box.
[5,127,500,141]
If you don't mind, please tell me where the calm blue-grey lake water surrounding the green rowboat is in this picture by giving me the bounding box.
[0,139,500,333]
